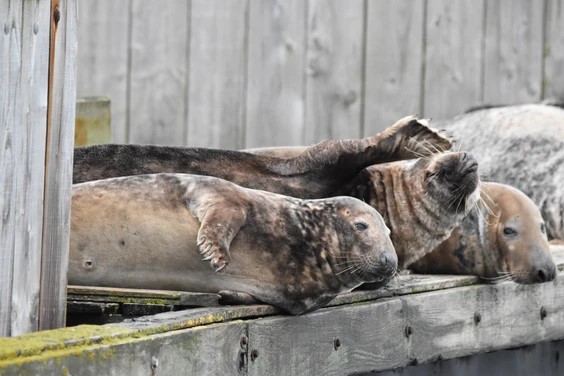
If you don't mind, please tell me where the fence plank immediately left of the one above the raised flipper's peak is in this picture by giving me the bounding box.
[305,0,365,144]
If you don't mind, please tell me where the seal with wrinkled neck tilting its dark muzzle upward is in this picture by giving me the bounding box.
[247,147,480,270]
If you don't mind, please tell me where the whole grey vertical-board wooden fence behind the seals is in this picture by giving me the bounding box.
[78,0,564,149]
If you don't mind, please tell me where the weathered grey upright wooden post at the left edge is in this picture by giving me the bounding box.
[0,0,77,336]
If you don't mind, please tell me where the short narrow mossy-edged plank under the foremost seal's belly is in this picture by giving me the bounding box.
[67,285,220,307]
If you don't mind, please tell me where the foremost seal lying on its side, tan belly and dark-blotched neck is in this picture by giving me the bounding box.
[68,174,397,314]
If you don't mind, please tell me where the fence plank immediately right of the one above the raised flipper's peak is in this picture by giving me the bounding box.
[423,0,485,119]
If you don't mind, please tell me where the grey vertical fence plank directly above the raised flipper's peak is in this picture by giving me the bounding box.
[364,0,425,136]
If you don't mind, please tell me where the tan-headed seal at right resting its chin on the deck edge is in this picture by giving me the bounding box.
[410,183,556,283]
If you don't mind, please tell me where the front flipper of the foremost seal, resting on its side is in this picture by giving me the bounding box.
[196,204,247,272]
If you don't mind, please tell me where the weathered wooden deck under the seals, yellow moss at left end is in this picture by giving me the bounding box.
[0,247,564,375]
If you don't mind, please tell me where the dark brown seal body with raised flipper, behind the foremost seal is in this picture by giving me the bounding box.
[73,116,452,198]
